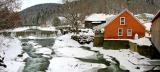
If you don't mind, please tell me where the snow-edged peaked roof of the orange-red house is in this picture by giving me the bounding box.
[105,9,145,28]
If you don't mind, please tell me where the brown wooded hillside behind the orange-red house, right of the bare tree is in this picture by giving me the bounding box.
[75,0,160,14]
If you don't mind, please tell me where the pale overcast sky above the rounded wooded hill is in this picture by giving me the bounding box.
[21,0,62,10]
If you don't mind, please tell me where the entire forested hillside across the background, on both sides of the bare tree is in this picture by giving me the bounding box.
[21,0,160,25]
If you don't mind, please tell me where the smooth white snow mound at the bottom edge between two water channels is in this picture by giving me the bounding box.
[47,57,106,72]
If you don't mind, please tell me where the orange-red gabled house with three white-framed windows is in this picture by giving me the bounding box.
[104,10,145,39]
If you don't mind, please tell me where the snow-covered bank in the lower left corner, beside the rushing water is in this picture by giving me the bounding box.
[0,36,24,72]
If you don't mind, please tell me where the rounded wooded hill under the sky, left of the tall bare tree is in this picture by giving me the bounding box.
[20,3,60,26]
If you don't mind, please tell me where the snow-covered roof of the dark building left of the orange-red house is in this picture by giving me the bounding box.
[85,13,111,21]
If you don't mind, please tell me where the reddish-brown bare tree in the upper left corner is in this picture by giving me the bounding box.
[0,0,21,30]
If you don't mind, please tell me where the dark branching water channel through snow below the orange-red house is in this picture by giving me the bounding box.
[77,46,129,72]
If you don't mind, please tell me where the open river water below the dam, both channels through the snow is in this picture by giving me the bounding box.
[21,39,128,72]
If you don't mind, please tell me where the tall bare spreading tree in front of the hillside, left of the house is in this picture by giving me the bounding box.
[60,0,91,34]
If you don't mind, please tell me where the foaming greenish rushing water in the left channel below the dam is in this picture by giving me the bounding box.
[21,39,54,72]
